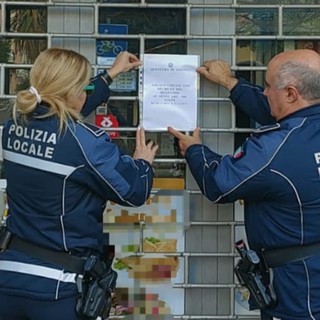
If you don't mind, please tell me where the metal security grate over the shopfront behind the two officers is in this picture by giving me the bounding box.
[0,0,320,320]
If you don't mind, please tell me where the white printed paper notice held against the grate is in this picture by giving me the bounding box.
[142,54,199,131]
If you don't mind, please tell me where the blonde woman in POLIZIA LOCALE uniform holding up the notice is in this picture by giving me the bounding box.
[0,48,158,320]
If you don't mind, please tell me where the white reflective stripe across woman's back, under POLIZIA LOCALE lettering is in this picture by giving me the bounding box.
[3,150,76,176]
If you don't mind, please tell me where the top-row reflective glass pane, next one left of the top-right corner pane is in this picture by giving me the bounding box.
[236,8,278,35]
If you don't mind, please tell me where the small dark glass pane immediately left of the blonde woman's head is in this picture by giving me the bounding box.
[4,68,30,95]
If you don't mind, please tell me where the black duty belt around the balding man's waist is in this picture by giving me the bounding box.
[262,242,320,268]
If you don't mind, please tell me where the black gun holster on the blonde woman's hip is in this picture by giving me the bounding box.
[76,256,117,320]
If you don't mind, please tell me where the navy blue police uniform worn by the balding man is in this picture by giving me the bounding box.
[186,80,320,320]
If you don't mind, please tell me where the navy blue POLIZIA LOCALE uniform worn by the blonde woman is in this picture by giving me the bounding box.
[0,77,153,319]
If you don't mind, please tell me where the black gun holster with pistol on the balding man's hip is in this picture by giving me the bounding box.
[234,240,277,310]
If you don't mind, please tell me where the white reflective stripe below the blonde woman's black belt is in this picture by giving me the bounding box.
[0,260,77,283]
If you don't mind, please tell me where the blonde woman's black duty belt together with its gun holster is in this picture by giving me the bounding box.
[0,227,117,320]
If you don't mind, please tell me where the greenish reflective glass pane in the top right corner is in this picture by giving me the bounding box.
[283,8,320,36]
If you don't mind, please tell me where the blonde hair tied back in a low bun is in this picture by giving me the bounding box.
[13,48,91,130]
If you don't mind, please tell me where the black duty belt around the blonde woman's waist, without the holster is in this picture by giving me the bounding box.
[0,228,87,274]
